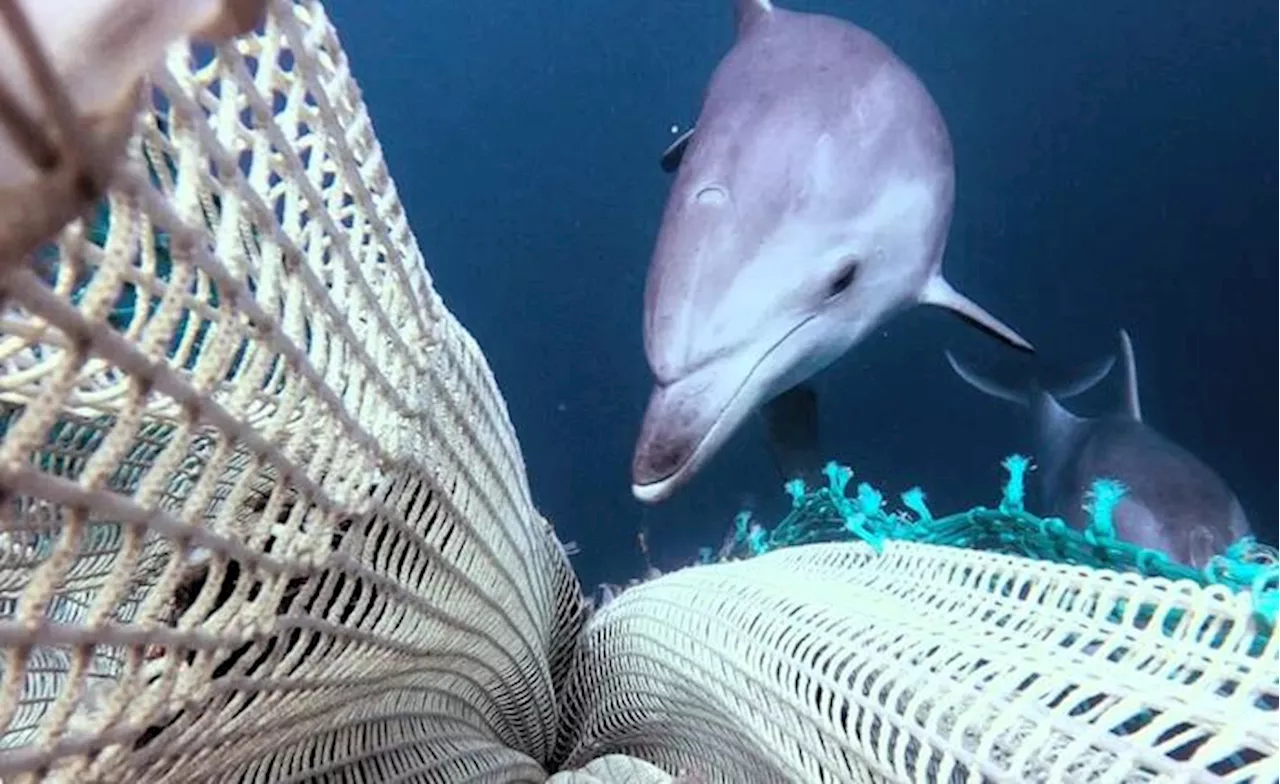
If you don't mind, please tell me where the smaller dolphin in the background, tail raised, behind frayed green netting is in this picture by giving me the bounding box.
[946,329,1252,569]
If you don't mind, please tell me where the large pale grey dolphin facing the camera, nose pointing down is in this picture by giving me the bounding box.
[631,0,1032,502]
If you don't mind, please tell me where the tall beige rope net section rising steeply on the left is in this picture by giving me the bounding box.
[0,1,581,781]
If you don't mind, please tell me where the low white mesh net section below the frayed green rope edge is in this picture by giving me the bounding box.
[562,539,1280,784]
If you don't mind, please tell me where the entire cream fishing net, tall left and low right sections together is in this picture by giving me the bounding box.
[0,0,1280,784]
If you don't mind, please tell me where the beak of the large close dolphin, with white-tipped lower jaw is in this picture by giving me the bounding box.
[631,368,750,503]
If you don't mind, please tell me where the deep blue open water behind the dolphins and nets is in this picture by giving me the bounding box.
[326,0,1280,588]
